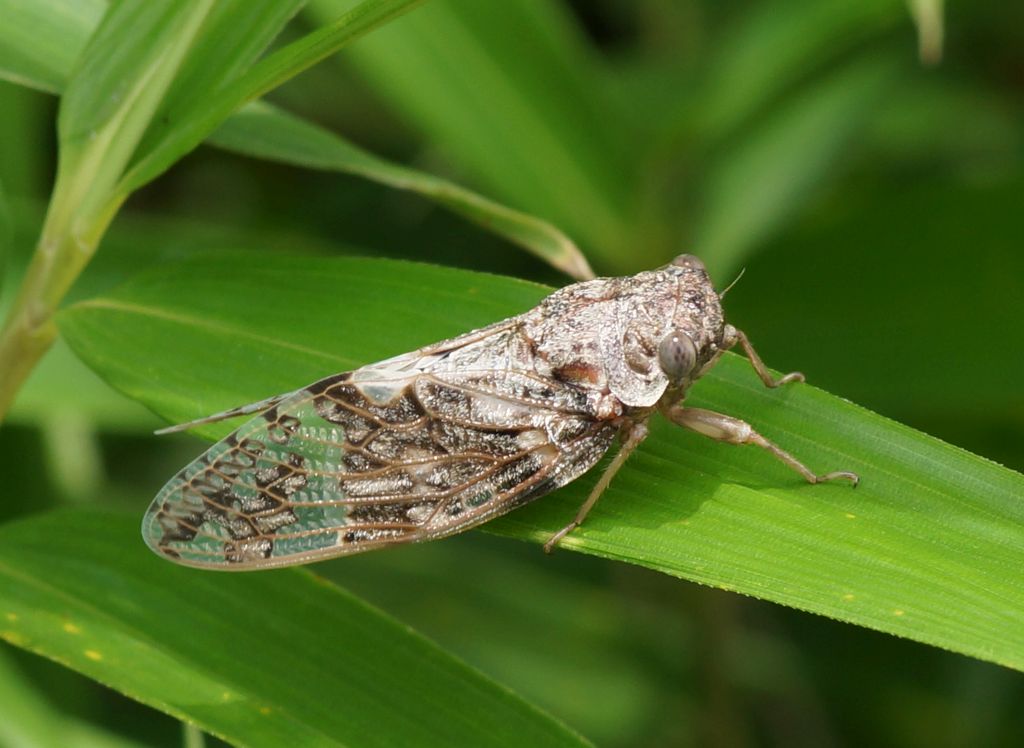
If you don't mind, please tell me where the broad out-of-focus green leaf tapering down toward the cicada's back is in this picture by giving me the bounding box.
[308,0,638,266]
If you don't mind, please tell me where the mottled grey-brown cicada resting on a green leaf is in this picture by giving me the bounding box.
[142,254,858,570]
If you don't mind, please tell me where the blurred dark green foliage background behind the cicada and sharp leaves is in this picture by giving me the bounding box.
[0,0,1024,746]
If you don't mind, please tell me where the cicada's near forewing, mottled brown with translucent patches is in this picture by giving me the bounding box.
[143,364,615,569]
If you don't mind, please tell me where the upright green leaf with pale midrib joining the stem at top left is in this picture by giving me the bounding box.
[17,0,422,243]
